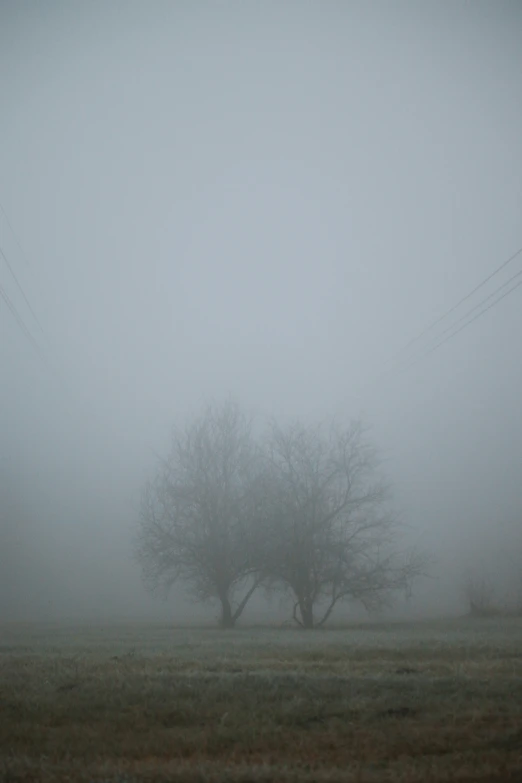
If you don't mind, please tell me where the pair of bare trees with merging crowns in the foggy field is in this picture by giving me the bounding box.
[135,399,426,628]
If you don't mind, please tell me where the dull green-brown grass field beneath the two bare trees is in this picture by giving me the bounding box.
[0,619,522,783]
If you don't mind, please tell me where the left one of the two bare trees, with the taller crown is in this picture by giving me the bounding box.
[136,400,260,628]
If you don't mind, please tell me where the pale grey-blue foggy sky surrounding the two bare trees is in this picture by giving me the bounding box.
[0,0,522,621]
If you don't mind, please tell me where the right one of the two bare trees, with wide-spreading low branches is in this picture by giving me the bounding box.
[261,422,425,628]
